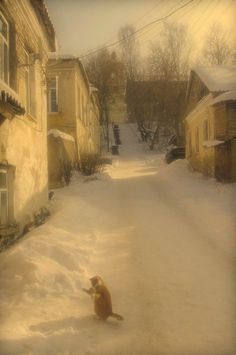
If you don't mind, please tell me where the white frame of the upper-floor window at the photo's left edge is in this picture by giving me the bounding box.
[0,11,10,85]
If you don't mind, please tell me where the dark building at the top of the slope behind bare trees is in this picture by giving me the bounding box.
[126,80,187,143]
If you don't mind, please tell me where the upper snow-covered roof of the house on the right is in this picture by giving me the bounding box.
[193,65,236,92]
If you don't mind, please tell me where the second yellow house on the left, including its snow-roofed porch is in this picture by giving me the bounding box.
[47,56,100,187]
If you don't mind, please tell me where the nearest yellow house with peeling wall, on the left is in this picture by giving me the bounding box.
[0,0,55,244]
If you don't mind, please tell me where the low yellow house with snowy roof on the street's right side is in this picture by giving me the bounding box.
[185,66,236,181]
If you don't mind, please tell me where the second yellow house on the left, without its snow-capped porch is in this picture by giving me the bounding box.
[47,56,100,184]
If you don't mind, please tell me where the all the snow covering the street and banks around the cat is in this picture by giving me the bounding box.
[0,124,236,355]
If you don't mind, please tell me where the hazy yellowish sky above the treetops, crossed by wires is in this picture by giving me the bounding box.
[46,0,236,56]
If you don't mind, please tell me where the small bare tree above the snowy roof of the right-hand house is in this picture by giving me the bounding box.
[202,22,231,65]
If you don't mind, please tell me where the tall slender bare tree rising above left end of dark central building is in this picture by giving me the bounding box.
[118,25,139,80]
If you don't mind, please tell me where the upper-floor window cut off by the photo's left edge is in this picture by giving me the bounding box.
[0,13,9,84]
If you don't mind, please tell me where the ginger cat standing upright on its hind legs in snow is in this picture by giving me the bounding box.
[83,276,124,321]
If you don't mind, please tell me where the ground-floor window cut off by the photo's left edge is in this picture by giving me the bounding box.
[0,169,8,225]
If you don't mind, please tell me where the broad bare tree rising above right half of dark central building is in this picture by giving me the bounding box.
[148,23,191,81]
